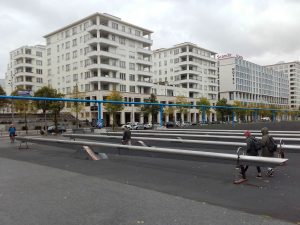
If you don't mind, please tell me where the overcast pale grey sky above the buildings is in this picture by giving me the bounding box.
[0,0,300,78]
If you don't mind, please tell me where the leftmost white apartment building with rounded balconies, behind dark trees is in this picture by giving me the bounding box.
[5,45,46,95]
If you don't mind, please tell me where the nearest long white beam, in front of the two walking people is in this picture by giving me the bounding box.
[16,137,288,167]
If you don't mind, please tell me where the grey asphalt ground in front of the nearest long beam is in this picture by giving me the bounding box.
[0,130,300,225]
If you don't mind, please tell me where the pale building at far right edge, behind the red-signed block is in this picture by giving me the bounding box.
[266,61,300,110]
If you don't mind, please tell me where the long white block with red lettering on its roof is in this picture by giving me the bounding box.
[219,54,289,109]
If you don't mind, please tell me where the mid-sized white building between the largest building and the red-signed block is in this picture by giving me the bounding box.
[153,42,218,103]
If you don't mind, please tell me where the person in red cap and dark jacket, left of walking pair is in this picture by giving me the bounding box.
[234,130,261,184]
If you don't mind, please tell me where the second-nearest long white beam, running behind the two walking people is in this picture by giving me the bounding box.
[63,134,300,151]
